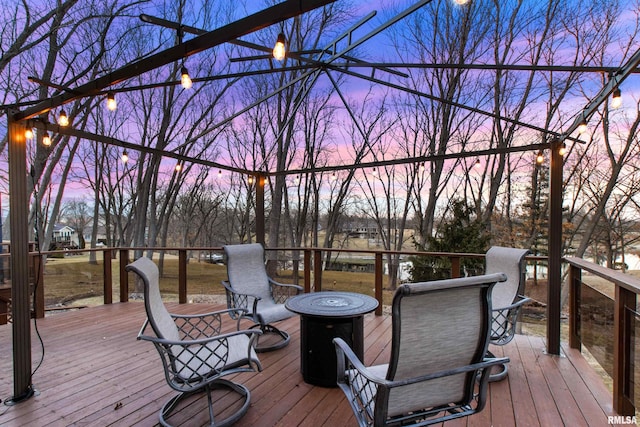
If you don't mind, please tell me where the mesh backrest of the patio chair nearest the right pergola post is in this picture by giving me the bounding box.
[485,246,529,310]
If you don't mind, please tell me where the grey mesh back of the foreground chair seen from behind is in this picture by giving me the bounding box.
[376,274,506,416]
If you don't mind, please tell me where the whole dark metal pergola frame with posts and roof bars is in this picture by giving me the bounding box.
[7,0,640,403]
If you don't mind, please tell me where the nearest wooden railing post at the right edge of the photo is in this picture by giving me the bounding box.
[613,285,636,415]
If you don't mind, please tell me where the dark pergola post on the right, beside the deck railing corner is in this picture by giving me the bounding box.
[547,139,564,355]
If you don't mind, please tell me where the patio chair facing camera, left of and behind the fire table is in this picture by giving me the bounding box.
[222,243,303,352]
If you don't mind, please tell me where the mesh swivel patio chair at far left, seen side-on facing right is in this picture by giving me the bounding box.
[126,257,262,426]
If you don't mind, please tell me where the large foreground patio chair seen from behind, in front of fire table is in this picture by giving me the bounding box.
[333,274,508,427]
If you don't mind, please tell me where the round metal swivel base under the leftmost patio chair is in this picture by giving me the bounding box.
[159,379,251,427]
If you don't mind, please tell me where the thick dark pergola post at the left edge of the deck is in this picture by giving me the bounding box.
[6,114,34,404]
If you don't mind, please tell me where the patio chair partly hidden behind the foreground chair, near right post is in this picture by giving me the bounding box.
[485,246,530,381]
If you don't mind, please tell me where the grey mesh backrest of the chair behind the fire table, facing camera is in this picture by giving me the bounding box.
[223,243,271,302]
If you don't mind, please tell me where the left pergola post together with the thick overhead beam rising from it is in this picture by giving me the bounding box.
[7,0,335,402]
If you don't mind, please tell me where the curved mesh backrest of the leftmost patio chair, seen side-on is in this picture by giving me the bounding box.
[126,257,180,341]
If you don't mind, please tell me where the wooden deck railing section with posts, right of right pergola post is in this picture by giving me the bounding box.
[565,257,640,416]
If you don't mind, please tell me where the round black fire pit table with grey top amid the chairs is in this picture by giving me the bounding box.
[285,291,378,387]
